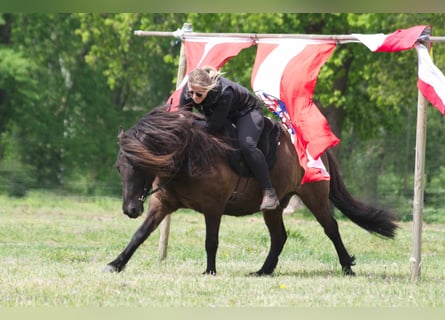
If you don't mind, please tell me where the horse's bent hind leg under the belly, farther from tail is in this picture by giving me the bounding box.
[255,208,287,276]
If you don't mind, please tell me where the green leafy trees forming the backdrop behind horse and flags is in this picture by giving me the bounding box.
[0,13,445,219]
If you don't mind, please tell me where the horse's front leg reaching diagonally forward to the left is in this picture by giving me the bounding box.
[104,197,172,272]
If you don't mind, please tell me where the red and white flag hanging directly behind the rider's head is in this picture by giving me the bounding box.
[167,37,255,110]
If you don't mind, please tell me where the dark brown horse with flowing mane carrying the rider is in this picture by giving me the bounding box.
[105,106,397,275]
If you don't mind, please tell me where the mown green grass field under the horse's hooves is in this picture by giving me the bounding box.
[0,192,445,307]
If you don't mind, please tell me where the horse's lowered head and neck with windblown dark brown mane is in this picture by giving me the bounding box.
[116,107,228,218]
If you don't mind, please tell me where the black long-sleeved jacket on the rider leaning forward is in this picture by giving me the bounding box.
[180,77,261,132]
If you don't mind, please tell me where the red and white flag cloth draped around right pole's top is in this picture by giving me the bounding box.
[353,25,445,115]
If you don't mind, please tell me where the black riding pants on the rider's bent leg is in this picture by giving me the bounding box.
[236,108,272,189]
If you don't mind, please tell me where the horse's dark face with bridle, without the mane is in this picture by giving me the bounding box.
[116,129,154,218]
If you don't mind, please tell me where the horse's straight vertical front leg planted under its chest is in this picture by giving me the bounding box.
[204,213,221,276]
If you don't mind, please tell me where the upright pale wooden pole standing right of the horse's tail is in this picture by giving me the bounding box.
[410,91,426,281]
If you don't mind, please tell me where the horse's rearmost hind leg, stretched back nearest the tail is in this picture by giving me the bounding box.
[299,181,355,275]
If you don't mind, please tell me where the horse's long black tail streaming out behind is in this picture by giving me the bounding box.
[326,151,398,238]
